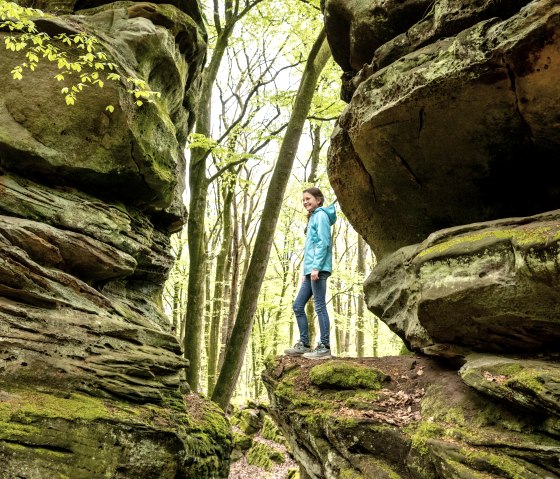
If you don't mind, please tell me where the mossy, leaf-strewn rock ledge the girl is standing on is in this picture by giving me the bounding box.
[263,356,560,479]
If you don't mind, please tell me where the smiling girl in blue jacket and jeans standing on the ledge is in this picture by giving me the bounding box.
[284,187,336,359]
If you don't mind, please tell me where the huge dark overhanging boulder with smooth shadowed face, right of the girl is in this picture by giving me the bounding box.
[327,0,560,257]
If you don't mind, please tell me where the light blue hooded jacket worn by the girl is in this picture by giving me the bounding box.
[303,204,336,275]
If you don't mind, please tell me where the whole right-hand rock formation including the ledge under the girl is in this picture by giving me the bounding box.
[264,0,560,479]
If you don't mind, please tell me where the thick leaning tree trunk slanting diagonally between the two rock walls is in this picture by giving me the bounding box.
[212,30,331,410]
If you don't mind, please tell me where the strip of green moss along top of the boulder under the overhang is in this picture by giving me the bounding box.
[418,225,560,258]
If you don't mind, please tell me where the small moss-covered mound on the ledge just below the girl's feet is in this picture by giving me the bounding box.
[309,361,389,389]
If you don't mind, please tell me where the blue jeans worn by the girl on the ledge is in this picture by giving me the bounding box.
[294,271,331,347]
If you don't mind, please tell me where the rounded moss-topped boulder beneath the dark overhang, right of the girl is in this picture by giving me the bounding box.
[364,210,560,356]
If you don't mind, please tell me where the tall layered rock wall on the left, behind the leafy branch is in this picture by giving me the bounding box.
[0,0,231,479]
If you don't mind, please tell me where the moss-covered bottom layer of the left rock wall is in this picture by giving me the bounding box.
[0,385,231,479]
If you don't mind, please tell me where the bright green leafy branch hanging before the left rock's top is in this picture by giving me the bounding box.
[0,0,161,108]
